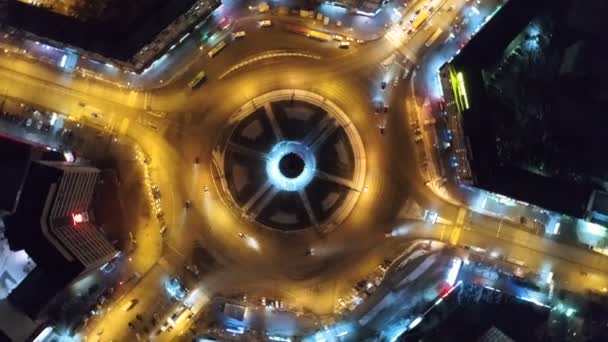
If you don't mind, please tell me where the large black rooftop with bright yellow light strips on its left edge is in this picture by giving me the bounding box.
[441,0,608,218]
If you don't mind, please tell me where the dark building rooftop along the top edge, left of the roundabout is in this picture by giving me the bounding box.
[0,0,220,67]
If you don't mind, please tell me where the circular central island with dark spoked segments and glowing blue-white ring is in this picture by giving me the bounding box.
[213,90,366,232]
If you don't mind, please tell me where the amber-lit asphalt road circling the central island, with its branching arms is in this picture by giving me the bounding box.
[0,1,608,341]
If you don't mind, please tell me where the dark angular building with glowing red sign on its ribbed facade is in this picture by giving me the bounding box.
[5,161,117,319]
